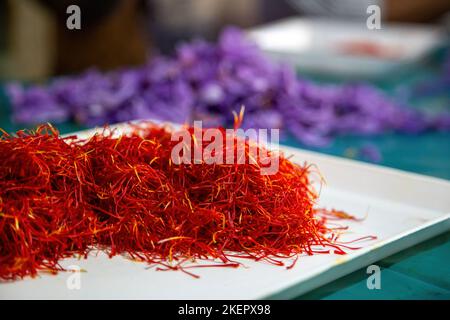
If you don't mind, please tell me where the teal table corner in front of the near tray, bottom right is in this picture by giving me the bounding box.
[297,232,450,299]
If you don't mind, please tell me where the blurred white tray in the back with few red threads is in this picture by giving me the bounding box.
[248,17,444,77]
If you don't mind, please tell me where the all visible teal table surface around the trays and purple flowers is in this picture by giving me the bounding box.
[0,48,450,299]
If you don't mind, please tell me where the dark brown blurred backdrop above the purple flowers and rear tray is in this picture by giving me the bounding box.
[0,0,450,80]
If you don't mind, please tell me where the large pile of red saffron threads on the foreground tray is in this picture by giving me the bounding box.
[0,122,372,280]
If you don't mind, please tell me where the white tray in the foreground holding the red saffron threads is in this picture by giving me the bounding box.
[0,125,450,299]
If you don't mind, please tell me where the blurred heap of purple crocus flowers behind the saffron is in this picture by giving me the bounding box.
[8,28,450,146]
